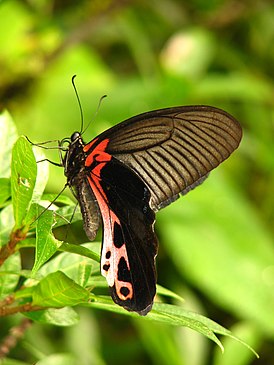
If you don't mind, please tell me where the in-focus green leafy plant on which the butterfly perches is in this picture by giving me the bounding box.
[0,113,256,356]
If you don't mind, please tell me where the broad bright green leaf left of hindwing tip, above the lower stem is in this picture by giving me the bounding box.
[32,271,89,308]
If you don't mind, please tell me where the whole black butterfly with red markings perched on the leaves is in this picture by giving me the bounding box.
[62,106,242,315]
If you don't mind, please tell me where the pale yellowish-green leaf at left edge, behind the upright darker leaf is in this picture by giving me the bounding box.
[0,111,18,177]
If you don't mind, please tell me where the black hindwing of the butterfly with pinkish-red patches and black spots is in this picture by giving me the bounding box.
[84,143,158,315]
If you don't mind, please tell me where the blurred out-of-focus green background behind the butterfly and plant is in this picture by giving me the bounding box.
[0,0,274,365]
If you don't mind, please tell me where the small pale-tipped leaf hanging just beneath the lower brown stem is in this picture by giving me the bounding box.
[24,307,79,326]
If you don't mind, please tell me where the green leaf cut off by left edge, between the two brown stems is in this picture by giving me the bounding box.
[0,252,21,299]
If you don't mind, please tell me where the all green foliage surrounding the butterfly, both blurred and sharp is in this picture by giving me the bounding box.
[0,0,274,365]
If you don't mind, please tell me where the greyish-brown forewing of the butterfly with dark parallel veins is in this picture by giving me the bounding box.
[98,106,242,211]
